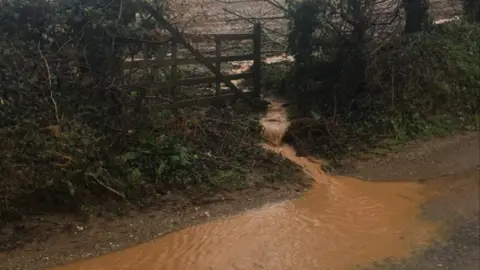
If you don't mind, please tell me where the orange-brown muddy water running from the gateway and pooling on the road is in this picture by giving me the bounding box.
[57,99,437,270]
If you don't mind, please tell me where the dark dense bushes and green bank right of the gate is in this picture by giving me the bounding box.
[284,0,480,162]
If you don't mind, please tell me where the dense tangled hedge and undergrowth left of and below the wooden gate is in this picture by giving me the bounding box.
[0,0,298,215]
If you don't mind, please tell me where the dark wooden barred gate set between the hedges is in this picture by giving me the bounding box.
[123,24,261,108]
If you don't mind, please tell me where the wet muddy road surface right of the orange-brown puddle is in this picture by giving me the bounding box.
[351,133,480,270]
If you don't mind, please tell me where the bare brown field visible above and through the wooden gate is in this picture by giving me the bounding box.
[164,0,462,54]
